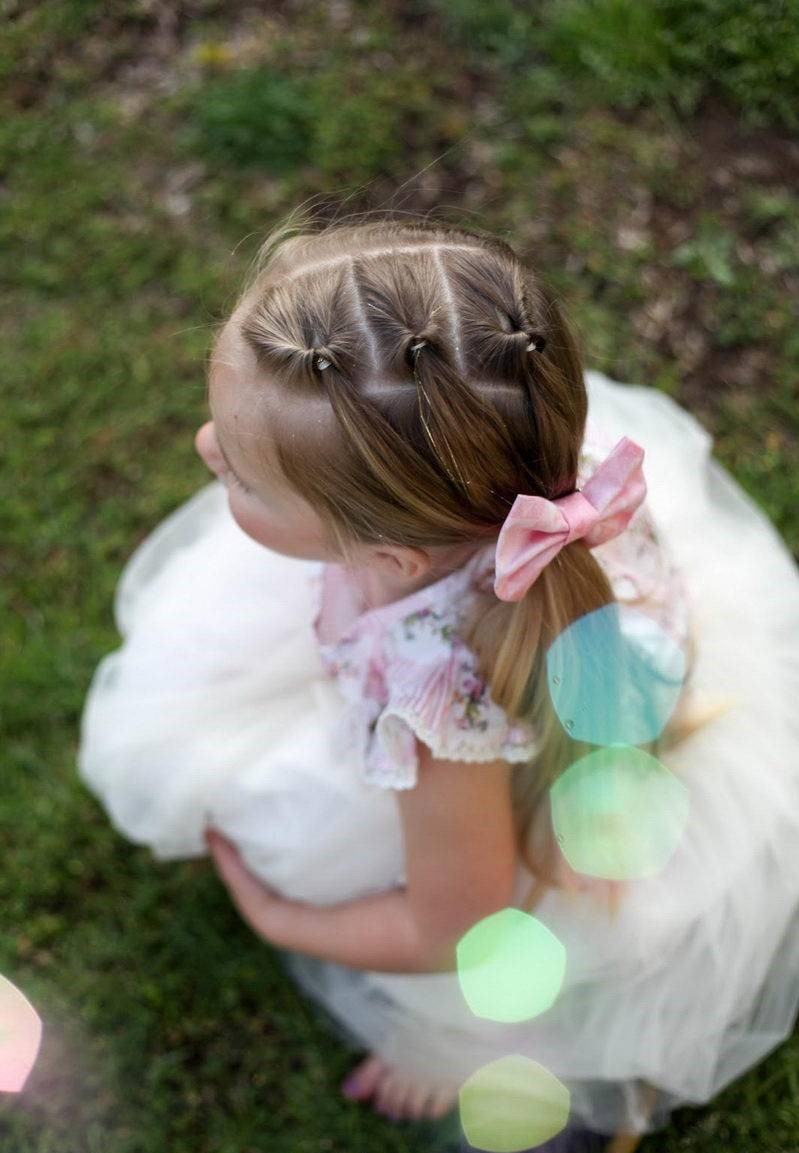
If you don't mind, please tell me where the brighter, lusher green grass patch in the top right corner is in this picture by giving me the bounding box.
[436,0,799,129]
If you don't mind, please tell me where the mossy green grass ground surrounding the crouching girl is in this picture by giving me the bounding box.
[0,0,799,1153]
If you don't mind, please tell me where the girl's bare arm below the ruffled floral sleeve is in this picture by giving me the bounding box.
[205,743,517,973]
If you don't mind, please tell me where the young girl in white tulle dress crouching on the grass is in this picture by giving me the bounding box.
[78,217,799,1150]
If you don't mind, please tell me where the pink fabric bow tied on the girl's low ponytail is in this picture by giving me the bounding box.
[493,436,647,601]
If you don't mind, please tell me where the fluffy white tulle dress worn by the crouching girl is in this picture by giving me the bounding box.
[78,371,799,1133]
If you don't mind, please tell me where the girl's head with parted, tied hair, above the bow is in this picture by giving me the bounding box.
[197,220,587,590]
